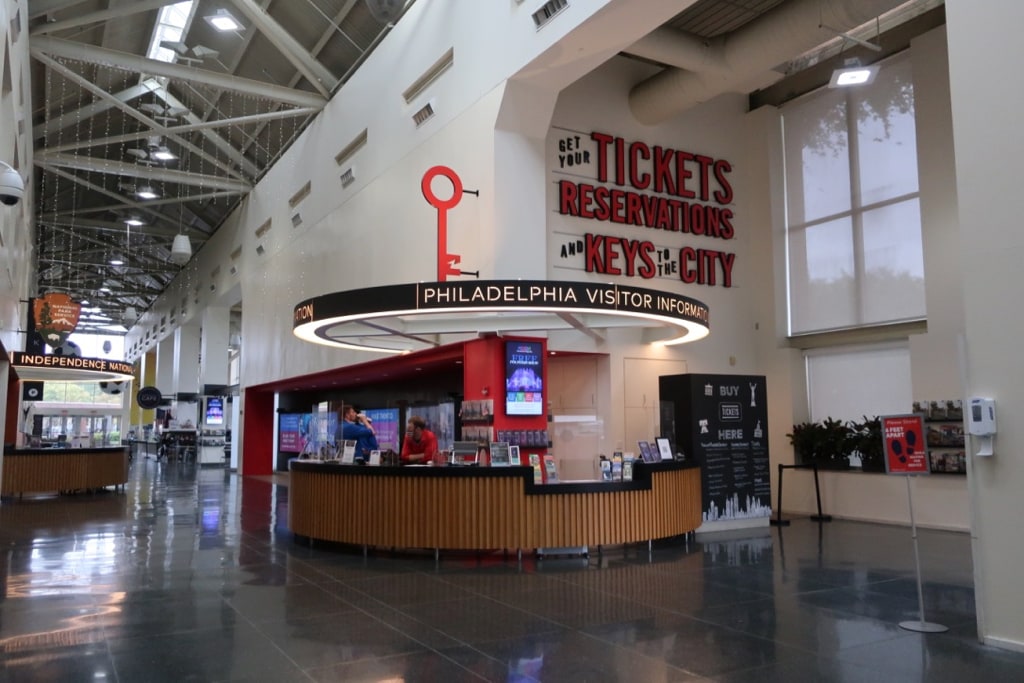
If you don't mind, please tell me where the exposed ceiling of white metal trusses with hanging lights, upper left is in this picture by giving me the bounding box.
[29,0,403,331]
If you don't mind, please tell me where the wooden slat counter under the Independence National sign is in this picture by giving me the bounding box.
[0,446,128,496]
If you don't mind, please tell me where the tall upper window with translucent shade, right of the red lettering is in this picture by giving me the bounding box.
[782,56,925,335]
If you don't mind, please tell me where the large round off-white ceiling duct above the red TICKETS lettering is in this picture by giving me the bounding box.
[627,0,904,125]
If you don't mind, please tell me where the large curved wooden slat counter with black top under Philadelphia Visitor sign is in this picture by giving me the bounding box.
[288,460,700,549]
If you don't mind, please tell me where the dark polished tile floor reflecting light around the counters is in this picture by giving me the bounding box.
[0,460,1024,683]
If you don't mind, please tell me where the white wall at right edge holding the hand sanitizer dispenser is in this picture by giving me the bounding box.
[946,0,1024,650]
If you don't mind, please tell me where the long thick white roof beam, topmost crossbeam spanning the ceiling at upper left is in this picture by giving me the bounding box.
[30,36,327,109]
